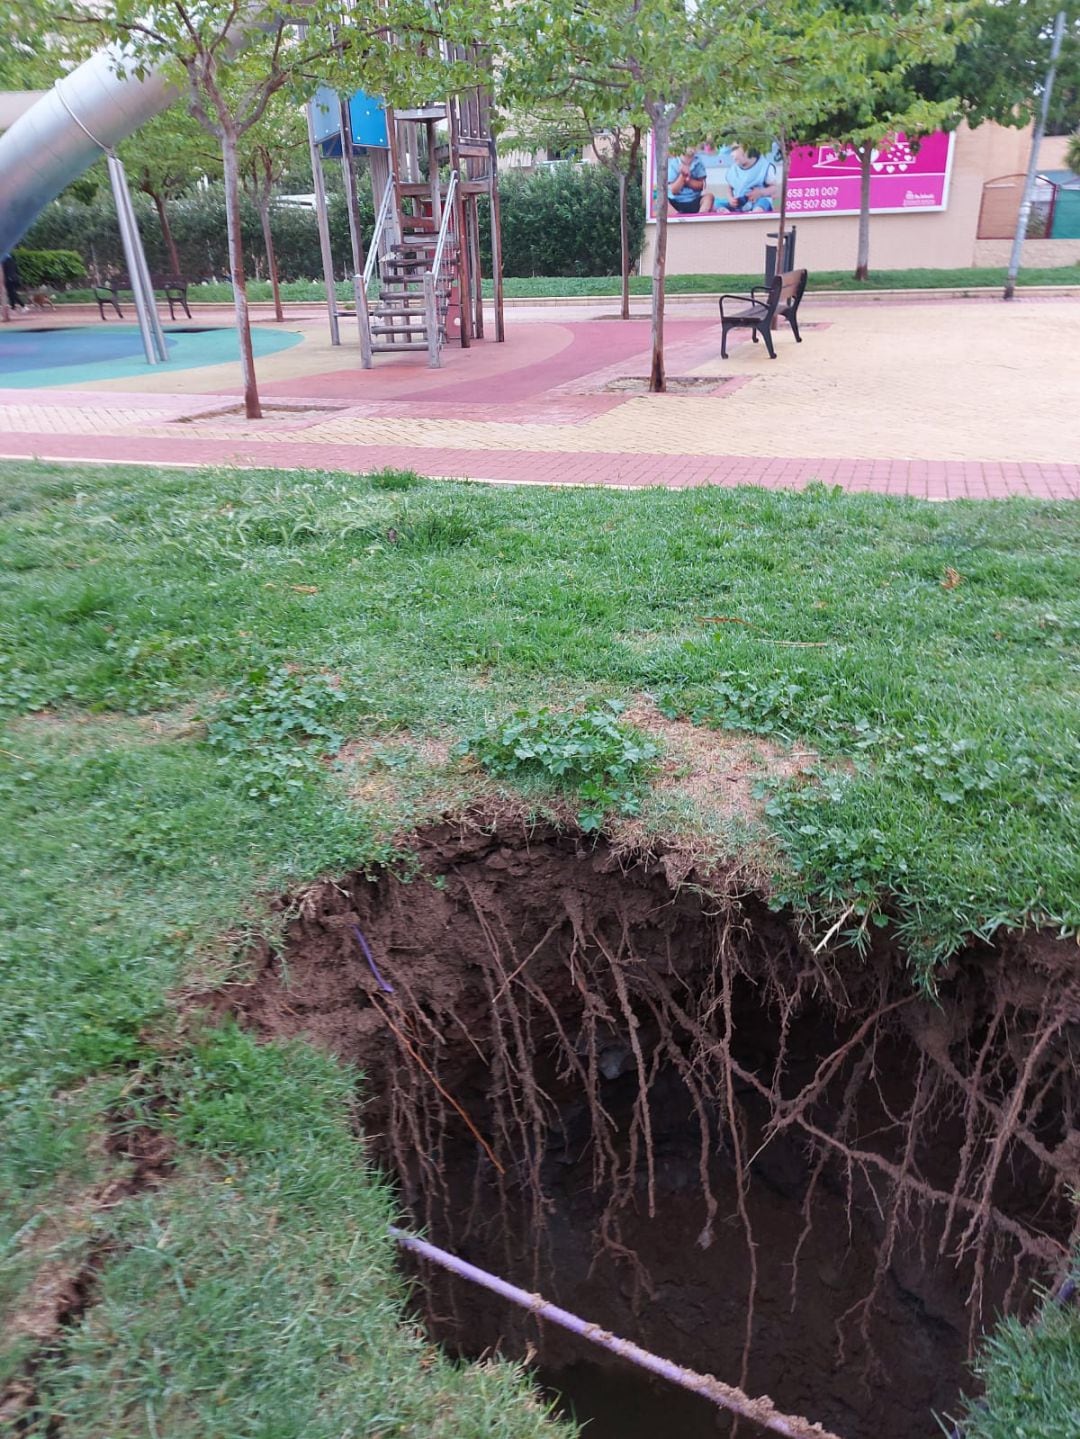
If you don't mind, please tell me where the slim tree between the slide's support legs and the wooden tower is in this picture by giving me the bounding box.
[94,0,479,420]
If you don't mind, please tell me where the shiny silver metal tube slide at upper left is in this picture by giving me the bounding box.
[0,46,175,255]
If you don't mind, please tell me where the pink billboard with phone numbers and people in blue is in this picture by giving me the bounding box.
[647,132,952,220]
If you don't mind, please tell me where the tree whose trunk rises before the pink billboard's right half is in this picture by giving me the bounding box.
[801,0,968,279]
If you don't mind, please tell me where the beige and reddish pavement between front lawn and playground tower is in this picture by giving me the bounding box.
[0,299,1080,499]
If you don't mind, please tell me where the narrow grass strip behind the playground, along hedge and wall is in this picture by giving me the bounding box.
[48,265,1080,304]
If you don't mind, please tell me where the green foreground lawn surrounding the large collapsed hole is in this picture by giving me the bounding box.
[0,463,1080,1439]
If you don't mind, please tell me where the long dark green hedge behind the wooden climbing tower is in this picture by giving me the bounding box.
[23,164,644,283]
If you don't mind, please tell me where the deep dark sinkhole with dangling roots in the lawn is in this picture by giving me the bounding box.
[226,822,1080,1439]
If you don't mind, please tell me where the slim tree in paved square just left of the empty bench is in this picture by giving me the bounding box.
[505,0,794,391]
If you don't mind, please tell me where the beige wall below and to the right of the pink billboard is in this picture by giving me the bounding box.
[641,125,1080,275]
